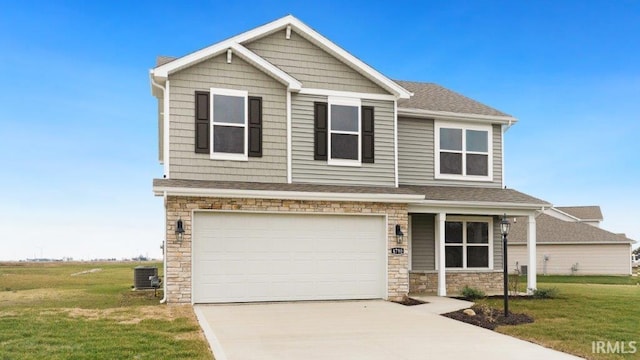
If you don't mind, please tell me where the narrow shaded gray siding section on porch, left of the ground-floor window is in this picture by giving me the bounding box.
[411,214,436,271]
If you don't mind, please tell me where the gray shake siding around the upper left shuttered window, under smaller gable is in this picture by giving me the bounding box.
[169,55,287,182]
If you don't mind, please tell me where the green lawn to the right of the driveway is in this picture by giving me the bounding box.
[479,276,640,359]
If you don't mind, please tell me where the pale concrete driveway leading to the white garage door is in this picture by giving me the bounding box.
[195,298,579,360]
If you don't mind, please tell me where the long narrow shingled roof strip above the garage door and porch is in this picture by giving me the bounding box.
[153,179,550,207]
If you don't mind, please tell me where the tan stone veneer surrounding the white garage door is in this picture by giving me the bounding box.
[165,196,409,303]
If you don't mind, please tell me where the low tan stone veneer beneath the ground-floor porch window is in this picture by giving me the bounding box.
[409,271,504,296]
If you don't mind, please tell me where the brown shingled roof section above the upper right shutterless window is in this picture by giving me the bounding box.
[396,80,516,122]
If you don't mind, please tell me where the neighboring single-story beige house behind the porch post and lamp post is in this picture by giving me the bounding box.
[508,206,635,275]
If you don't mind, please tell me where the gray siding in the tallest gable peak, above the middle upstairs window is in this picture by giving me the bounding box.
[243,30,388,94]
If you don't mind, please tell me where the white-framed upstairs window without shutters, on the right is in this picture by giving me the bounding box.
[434,122,493,181]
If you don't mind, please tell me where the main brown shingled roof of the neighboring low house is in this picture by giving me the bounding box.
[508,214,635,244]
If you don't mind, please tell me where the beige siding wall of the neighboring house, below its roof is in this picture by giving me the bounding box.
[507,244,631,275]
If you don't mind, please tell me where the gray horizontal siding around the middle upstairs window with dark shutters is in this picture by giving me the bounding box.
[291,94,395,186]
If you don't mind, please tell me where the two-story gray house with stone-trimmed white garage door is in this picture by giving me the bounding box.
[150,16,550,303]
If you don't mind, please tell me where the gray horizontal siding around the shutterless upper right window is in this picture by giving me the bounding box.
[398,117,502,187]
